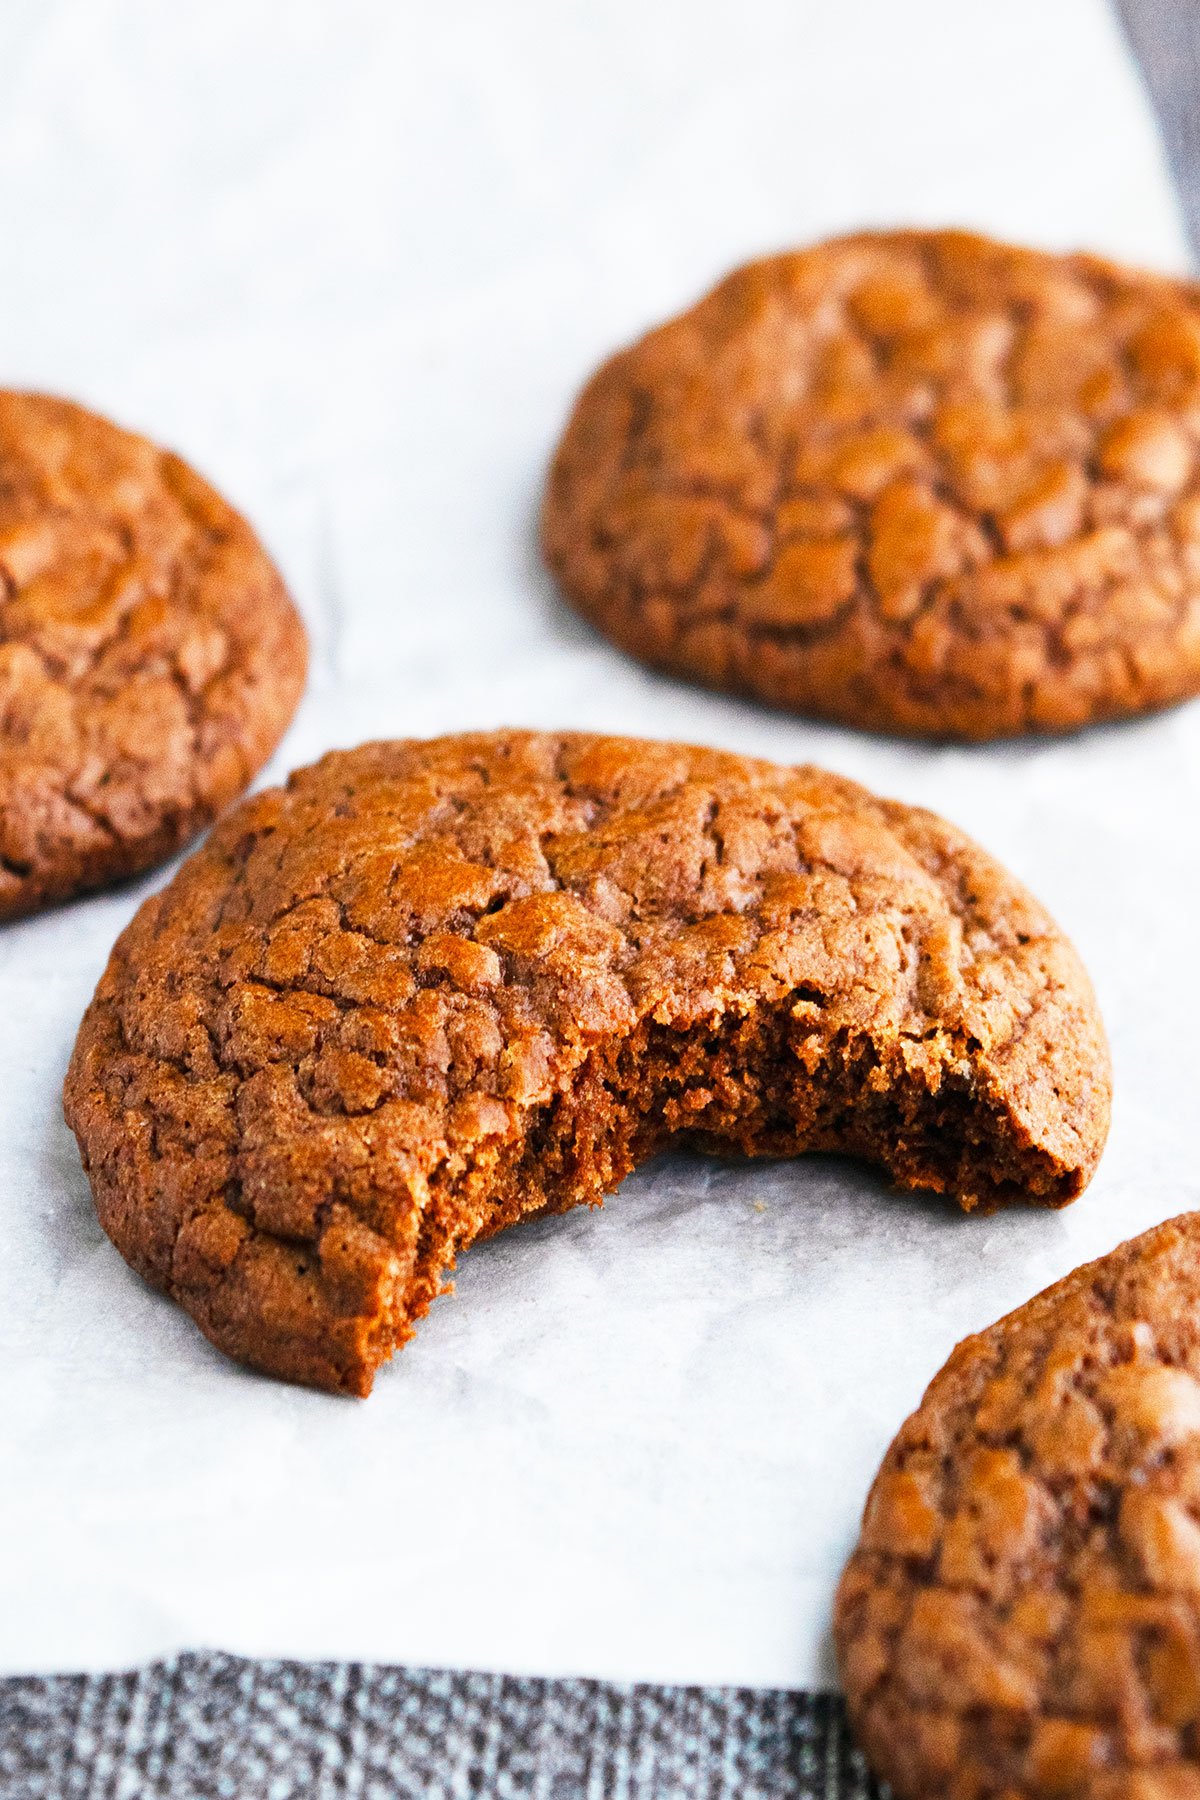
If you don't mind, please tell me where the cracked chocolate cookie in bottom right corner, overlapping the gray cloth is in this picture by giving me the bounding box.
[837,1213,1200,1800]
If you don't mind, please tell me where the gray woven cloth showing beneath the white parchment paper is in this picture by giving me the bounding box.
[0,0,1200,1800]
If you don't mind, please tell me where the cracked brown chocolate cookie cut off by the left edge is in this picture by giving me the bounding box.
[0,392,306,918]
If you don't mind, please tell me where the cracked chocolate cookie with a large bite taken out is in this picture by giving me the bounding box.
[67,733,1108,1393]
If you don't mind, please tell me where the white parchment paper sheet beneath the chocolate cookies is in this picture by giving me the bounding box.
[0,0,1200,1683]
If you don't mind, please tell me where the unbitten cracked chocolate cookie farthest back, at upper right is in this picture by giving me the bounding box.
[542,232,1200,738]
